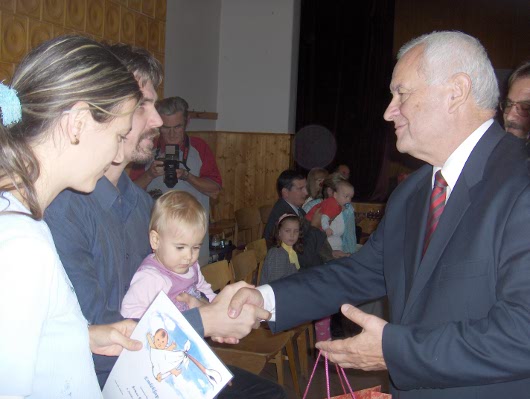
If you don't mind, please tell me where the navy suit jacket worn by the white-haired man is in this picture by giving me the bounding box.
[271,123,530,399]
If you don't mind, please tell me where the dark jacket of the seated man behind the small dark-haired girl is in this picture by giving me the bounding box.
[263,199,332,269]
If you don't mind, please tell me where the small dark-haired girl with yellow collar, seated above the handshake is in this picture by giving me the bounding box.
[260,213,303,284]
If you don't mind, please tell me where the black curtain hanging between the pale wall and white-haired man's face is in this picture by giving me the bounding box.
[296,0,394,200]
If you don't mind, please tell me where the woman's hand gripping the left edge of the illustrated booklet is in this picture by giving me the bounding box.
[88,320,142,356]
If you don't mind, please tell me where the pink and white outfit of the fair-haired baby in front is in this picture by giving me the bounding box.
[121,254,216,318]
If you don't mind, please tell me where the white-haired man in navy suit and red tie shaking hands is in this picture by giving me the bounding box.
[230,32,530,399]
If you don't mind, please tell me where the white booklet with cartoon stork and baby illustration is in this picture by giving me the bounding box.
[103,292,232,399]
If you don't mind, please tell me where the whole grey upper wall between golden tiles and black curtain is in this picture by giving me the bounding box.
[164,0,300,133]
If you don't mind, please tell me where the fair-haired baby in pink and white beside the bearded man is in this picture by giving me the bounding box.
[121,190,215,318]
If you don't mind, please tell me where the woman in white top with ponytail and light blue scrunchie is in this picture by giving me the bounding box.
[0,36,142,398]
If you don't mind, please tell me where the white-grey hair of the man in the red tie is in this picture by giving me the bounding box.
[398,31,499,109]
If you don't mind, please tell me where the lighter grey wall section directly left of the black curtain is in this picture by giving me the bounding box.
[216,0,299,133]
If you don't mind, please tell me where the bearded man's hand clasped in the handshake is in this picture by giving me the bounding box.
[199,281,271,344]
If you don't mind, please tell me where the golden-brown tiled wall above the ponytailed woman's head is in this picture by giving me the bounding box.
[0,0,166,89]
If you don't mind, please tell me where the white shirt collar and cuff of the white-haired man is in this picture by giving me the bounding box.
[258,119,493,321]
